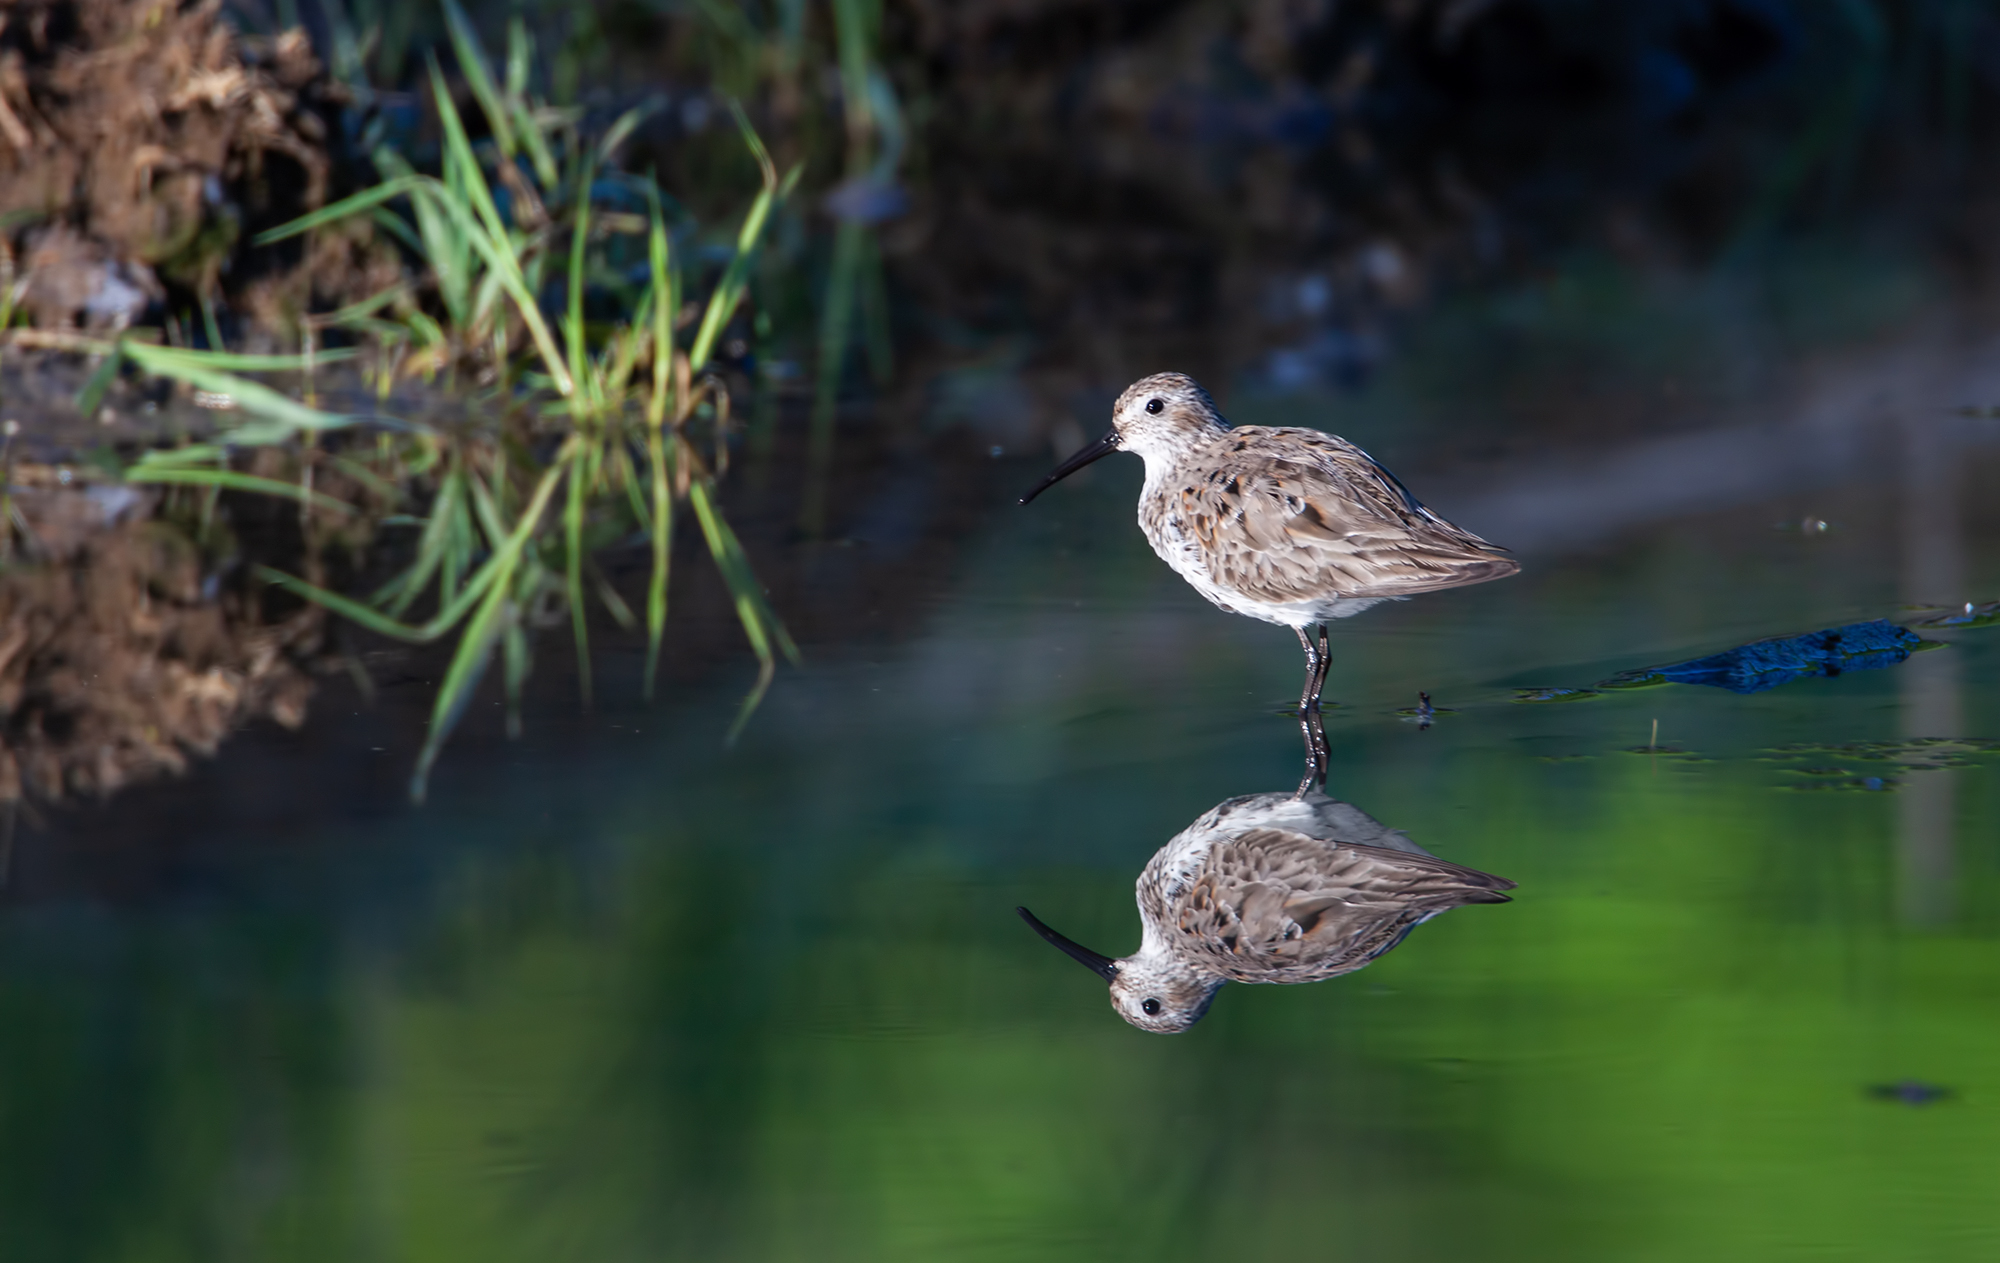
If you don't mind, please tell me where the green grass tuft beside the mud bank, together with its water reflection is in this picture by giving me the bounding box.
[119,22,800,801]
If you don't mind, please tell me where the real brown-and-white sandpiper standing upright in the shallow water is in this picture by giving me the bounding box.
[1020,374,1520,715]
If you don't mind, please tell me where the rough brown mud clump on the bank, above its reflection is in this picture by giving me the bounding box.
[0,0,400,338]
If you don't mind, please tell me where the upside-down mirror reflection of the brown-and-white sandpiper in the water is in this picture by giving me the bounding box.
[1014,791,1514,1035]
